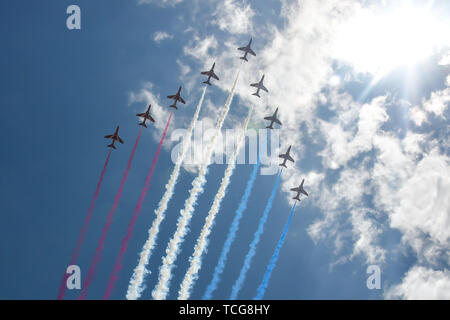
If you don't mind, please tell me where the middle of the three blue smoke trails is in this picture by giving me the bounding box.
[230,169,283,300]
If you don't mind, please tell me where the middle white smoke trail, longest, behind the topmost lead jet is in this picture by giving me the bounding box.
[152,71,240,300]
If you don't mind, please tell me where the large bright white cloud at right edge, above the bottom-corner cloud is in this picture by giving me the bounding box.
[390,149,450,262]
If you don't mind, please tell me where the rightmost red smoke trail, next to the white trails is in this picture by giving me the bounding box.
[103,112,173,300]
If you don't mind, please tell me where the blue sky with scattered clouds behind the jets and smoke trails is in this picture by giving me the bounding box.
[0,0,450,299]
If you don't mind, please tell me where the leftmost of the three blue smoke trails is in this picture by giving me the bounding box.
[202,155,261,300]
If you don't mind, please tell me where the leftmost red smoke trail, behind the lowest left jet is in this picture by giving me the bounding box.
[58,150,112,300]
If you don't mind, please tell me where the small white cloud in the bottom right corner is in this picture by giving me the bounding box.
[385,266,450,300]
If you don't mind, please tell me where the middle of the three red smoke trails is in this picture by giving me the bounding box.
[78,128,142,300]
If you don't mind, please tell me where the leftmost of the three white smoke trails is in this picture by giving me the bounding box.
[126,86,206,300]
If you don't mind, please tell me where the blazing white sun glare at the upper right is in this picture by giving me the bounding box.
[333,6,449,77]
